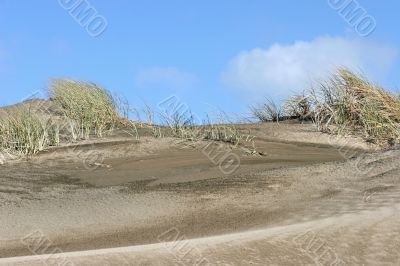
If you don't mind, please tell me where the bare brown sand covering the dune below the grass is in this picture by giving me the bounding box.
[0,124,400,265]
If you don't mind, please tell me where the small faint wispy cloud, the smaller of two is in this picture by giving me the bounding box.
[135,67,197,89]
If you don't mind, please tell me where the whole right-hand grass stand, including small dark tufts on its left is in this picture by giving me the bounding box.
[250,68,400,145]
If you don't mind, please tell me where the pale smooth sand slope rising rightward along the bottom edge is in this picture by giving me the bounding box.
[2,201,400,265]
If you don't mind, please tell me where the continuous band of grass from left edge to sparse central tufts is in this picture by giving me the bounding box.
[0,79,252,158]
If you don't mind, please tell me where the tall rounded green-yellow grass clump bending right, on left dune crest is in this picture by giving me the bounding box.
[50,80,120,139]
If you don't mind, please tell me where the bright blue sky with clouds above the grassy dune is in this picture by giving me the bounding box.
[0,0,400,115]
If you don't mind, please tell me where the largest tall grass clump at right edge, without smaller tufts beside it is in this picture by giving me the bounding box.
[311,68,400,145]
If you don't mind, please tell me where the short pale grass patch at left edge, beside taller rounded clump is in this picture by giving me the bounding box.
[0,110,59,155]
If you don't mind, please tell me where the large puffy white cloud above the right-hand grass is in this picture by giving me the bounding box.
[222,37,397,97]
